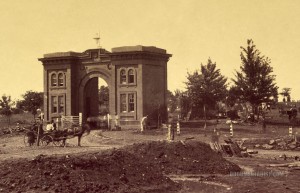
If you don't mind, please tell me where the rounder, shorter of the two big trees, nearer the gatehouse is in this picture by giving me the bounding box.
[186,58,227,119]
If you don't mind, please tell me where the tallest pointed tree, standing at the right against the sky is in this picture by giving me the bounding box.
[232,39,278,117]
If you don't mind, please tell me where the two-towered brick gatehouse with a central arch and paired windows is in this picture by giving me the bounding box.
[39,46,171,128]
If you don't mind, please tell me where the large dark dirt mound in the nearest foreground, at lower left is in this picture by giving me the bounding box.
[0,150,179,193]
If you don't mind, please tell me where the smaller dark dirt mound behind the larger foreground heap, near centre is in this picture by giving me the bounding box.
[126,140,241,174]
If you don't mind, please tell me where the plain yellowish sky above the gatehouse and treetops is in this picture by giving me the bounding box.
[0,0,300,100]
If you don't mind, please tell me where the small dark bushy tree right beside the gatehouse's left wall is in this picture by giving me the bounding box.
[17,90,43,119]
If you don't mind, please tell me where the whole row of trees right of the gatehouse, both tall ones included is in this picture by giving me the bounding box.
[168,39,291,118]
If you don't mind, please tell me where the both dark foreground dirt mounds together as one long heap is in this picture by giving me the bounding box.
[0,141,240,193]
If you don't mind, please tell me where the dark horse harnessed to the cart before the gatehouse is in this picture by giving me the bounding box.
[57,123,91,147]
